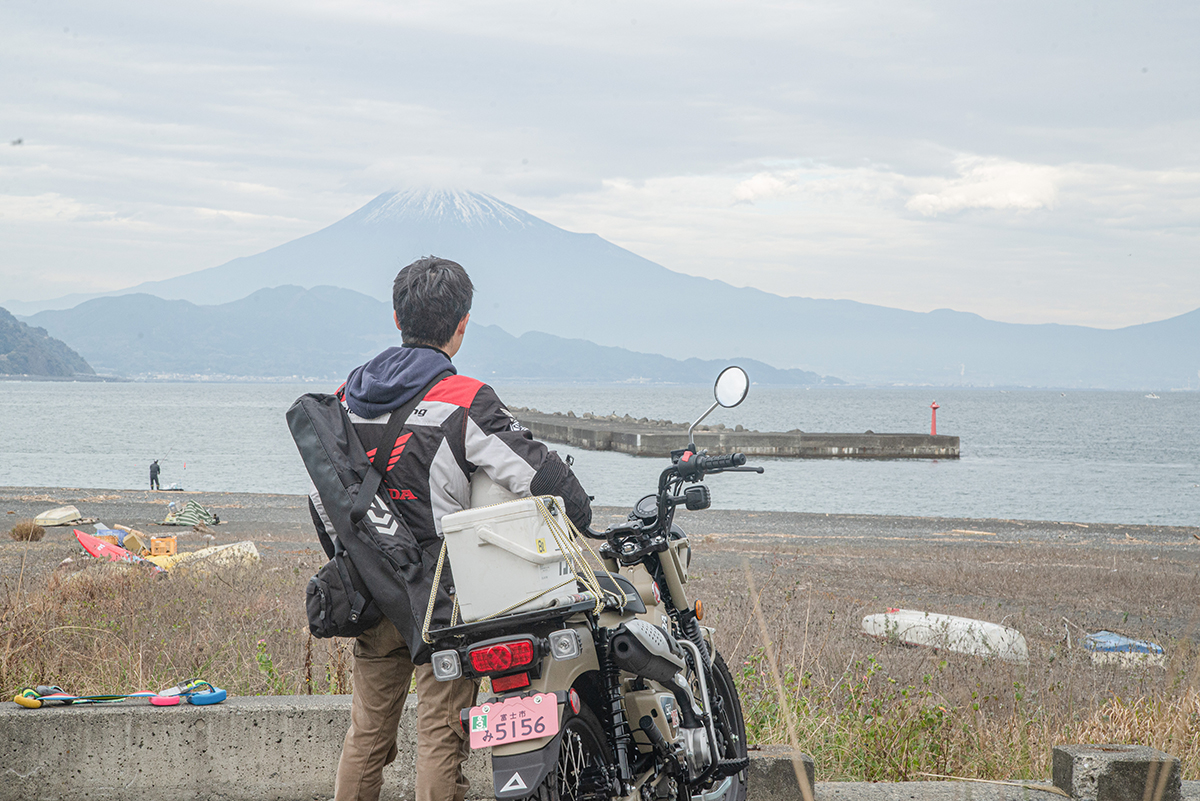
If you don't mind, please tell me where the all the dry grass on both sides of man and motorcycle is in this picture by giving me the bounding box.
[0,532,1200,779]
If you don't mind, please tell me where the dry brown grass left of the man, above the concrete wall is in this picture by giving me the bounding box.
[0,562,353,697]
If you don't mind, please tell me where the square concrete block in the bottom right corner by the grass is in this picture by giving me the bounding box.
[1052,745,1182,801]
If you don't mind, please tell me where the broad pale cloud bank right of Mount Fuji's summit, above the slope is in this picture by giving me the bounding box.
[523,155,1200,327]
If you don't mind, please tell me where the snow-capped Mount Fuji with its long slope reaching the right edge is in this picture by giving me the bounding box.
[4,189,1200,389]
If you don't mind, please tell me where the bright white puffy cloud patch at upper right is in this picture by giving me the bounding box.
[905,156,1063,217]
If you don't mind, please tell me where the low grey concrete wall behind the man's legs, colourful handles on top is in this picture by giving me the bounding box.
[0,695,816,801]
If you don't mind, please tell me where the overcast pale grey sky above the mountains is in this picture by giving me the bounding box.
[0,0,1200,327]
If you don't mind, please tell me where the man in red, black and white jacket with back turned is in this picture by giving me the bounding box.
[313,257,592,801]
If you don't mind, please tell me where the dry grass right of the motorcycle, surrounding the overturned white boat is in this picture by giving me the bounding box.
[696,546,1200,781]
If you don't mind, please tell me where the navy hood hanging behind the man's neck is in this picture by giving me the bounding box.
[346,347,458,420]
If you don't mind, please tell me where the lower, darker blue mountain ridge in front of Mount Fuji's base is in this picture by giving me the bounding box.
[21,287,842,386]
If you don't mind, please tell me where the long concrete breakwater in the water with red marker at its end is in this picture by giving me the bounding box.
[511,408,959,459]
